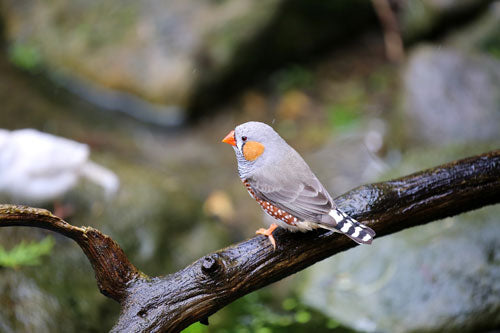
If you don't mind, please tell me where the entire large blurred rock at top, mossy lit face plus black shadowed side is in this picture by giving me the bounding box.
[0,0,374,121]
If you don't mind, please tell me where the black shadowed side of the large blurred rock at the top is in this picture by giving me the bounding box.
[190,0,377,116]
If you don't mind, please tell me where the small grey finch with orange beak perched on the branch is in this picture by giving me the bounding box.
[222,121,375,248]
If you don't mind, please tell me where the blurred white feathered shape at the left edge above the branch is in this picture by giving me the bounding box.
[0,129,120,204]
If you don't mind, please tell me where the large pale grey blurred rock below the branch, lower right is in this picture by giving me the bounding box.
[302,205,500,332]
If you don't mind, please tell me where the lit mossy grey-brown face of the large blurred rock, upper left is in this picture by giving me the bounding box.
[0,0,282,124]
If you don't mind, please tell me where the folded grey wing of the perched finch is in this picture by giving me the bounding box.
[247,161,334,222]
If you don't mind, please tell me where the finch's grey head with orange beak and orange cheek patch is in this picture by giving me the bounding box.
[222,121,289,178]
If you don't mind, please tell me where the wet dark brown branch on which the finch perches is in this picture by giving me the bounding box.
[0,150,500,332]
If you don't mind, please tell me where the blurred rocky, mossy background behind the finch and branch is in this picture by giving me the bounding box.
[0,0,500,333]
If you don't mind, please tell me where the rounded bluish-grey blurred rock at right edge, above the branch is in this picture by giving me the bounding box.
[403,47,500,144]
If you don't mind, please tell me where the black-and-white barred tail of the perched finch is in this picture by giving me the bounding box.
[328,208,375,244]
